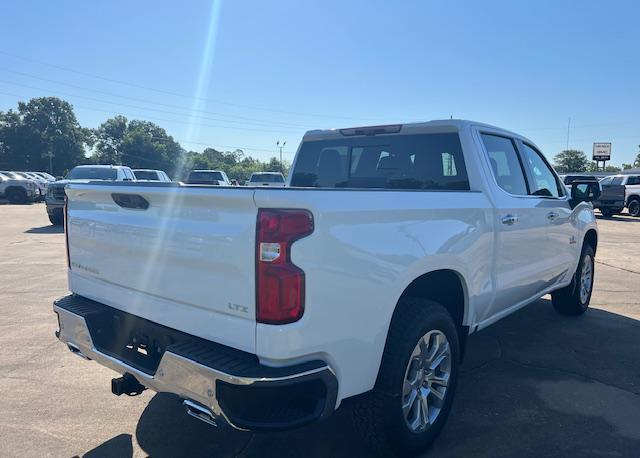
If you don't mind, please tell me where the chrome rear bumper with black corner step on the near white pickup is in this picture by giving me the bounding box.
[53,295,337,430]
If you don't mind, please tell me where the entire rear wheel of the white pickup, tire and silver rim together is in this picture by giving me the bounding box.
[354,298,460,456]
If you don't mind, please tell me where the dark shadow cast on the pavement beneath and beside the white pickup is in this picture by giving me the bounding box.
[87,299,640,458]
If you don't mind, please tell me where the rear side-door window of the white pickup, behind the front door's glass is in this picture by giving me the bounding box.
[481,134,529,196]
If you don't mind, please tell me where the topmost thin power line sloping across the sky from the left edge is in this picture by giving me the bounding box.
[0,50,381,121]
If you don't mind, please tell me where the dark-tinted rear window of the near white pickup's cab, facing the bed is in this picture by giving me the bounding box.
[291,133,469,191]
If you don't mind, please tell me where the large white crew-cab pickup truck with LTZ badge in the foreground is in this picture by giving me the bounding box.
[54,120,599,455]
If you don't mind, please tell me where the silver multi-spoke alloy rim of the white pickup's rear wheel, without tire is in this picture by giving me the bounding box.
[402,330,451,433]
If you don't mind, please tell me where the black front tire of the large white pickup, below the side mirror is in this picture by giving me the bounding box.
[551,243,595,316]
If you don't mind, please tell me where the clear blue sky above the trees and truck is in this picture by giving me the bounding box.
[0,0,640,165]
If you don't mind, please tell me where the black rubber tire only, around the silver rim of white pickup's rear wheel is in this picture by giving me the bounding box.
[352,297,460,456]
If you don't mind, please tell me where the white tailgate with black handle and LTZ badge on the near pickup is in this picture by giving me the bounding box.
[66,184,257,353]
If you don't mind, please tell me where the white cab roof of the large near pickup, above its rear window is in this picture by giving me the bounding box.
[303,119,525,140]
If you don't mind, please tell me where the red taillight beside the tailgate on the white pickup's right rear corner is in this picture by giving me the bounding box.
[256,208,313,324]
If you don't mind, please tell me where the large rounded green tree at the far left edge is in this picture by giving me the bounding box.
[0,97,93,175]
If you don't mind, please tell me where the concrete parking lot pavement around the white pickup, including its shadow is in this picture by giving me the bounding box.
[0,204,640,458]
